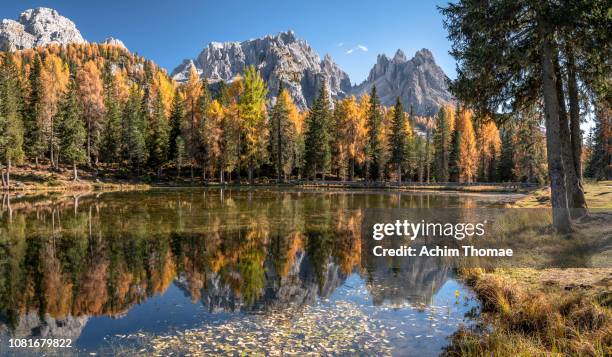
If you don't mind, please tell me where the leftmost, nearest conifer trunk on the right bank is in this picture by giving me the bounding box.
[540,34,572,233]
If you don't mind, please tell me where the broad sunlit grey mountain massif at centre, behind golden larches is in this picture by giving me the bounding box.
[172,31,351,109]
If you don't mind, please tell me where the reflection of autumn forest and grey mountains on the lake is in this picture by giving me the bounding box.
[0,189,506,354]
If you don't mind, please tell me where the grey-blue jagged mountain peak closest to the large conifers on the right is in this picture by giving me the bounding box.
[352,48,454,116]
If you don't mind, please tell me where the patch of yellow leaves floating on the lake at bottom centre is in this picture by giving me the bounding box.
[129,301,391,356]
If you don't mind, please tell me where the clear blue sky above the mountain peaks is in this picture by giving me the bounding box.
[0,0,455,82]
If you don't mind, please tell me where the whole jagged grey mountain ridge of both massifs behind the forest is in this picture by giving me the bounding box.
[171,31,454,116]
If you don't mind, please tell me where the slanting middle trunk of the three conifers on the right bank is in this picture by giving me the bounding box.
[553,50,586,218]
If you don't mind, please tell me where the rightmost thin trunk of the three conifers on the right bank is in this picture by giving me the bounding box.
[566,45,587,217]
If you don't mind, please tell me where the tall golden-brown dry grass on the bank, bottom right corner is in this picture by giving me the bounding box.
[444,269,612,356]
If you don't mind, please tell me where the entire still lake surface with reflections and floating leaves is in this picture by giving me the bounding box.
[0,189,507,356]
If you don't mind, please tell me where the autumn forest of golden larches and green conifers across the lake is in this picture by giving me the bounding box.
[0,44,560,186]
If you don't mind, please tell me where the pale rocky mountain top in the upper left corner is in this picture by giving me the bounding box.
[0,7,86,51]
